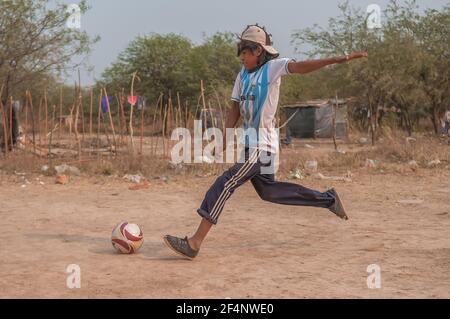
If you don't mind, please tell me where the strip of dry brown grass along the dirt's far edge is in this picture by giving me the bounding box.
[0,131,450,178]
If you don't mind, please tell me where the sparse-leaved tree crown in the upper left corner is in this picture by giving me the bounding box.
[0,0,99,100]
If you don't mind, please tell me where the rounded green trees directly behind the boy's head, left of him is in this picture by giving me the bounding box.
[98,33,239,110]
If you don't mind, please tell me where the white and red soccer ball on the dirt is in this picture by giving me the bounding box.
[111,222,144,254]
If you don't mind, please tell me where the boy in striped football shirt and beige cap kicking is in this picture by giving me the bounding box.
[164,24,368,260]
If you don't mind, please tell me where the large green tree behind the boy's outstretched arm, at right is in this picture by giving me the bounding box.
[293,0,450,140]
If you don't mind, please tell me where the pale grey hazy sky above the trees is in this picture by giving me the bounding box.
[60,0,450,86]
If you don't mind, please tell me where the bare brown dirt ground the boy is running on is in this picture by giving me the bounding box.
[0,143,450,298]
